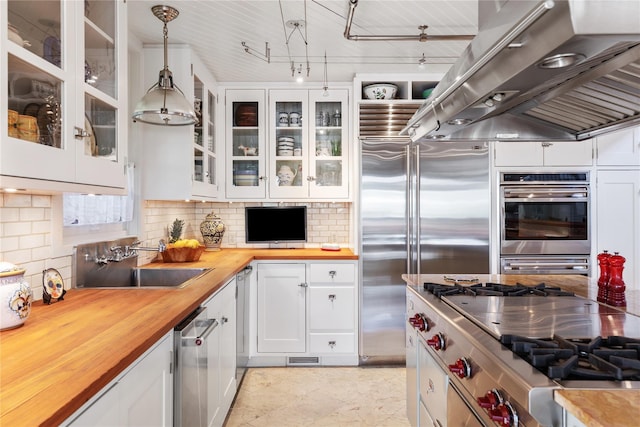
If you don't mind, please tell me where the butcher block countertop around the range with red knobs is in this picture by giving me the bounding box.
[403,274,640,427]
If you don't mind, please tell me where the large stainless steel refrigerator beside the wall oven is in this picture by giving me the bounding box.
[359,138,490,365]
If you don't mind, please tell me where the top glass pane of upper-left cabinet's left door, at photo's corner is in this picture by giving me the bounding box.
[6,0,63,67]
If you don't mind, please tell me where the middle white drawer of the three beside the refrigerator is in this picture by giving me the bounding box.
[309,286,355,331]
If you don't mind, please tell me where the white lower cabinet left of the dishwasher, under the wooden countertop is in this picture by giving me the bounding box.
[62,331,173,427]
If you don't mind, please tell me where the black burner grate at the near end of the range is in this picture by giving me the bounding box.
[500,335,640,381]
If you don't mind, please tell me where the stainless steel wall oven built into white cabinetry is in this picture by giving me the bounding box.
[500,172,591,274]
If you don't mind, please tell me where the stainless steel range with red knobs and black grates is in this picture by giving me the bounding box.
[407,283,640,426]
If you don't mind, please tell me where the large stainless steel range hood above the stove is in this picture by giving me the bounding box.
[401,0,640,141]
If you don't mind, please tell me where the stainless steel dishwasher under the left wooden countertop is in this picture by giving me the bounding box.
[173,307,219,427]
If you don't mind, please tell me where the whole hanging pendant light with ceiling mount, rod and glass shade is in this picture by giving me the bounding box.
[133,5,198,126]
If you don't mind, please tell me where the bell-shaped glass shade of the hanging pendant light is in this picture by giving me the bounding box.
[133,70,198,126]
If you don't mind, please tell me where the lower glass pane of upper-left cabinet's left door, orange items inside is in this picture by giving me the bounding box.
[7,55,63,148]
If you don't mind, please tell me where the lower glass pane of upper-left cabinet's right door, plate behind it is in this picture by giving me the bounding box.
[84,95,118,161]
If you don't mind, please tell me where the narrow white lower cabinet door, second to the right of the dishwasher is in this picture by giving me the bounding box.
[219,278,237,424]
